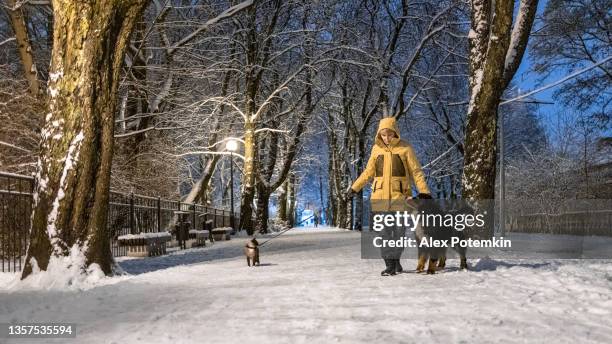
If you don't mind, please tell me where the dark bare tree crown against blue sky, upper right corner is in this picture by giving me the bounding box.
[530,0,612,121]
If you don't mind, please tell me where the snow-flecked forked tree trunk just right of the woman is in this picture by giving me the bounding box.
[462,0,537,200]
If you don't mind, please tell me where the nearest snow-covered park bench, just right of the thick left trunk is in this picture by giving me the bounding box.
[117,232,172,257]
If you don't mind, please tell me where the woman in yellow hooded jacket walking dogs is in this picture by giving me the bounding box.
[348,117,431,276]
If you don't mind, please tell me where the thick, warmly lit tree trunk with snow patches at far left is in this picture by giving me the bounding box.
[22,0,147,278]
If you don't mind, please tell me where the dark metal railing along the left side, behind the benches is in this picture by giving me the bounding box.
[0,172,239,272]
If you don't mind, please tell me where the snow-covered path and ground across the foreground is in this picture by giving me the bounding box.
[0,230,612,343]
